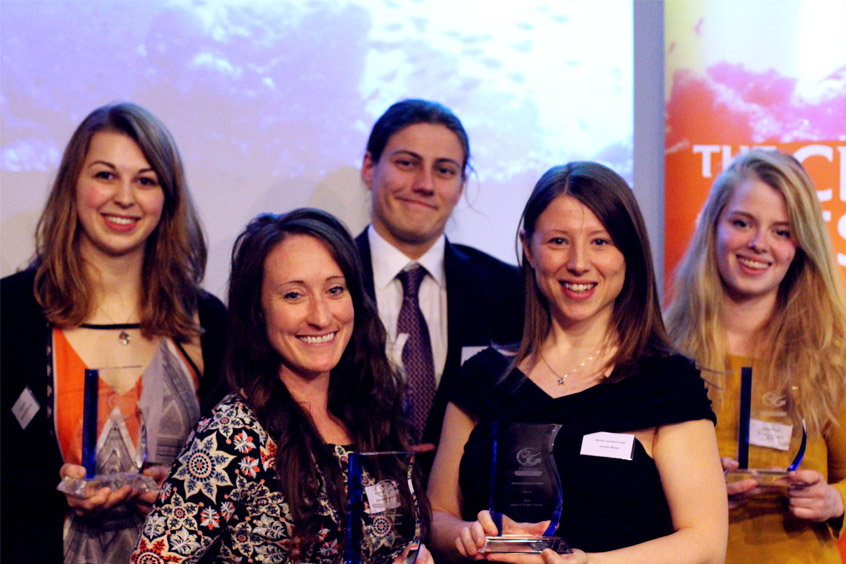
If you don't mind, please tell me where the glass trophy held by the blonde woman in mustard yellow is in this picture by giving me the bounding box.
[726,367,808,487]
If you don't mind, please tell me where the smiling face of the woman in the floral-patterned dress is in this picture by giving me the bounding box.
[261,235,354,382]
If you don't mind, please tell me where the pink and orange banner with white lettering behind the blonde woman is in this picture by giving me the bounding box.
[664,0,846,288]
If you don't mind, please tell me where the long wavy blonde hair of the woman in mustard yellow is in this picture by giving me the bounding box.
[667,150,846,433]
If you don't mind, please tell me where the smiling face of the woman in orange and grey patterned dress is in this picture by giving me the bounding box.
[76,131,165,258]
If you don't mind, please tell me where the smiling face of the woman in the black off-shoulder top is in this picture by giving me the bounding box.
[521,195,626,331]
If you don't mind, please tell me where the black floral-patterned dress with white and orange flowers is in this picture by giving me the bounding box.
[131,395,418,564]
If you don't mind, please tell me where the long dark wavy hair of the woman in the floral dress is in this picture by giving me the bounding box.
[224,208,427,545]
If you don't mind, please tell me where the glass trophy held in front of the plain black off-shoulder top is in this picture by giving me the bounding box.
[481,422,572,554]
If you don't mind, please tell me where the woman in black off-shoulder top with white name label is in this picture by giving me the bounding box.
[429,162,726,563]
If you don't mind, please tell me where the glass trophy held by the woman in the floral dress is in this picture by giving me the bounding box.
[345,451,421,564]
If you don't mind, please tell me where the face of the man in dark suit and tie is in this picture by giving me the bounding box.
[361,123,465,258]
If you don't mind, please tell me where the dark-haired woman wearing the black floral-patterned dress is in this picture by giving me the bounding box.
[133,208,429,563]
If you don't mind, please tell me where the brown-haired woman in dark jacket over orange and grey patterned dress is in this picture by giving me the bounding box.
[1,103,225,562]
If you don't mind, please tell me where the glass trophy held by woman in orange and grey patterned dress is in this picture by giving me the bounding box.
[56,366,159,497]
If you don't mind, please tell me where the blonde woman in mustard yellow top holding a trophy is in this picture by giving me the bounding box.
[667,150,846,564]
